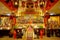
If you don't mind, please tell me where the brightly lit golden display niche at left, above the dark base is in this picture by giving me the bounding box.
[0,17,12,30]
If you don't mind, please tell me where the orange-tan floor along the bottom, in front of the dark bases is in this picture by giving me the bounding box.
[0,36,60,40]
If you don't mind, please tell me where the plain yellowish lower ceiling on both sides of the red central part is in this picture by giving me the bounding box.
[0,0,60,14]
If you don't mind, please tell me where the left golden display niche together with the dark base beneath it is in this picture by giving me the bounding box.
[0,17,12,36]
